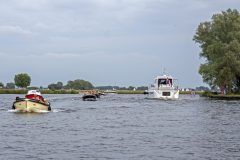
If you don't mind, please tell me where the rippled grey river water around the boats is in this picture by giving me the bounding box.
[0,94,240,160]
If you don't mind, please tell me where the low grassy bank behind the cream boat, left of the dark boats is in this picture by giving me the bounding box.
[0,89,79,94]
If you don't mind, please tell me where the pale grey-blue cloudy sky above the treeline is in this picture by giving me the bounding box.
[0,0,240,87]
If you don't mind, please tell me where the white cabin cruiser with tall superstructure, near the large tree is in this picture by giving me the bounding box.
[148,75,179,100]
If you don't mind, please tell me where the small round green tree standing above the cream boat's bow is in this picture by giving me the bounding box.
[14,73,31,88]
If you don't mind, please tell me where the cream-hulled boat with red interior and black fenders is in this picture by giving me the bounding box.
[12,90,51,112]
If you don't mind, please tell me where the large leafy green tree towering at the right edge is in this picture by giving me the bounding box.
[193,9,240,93]
